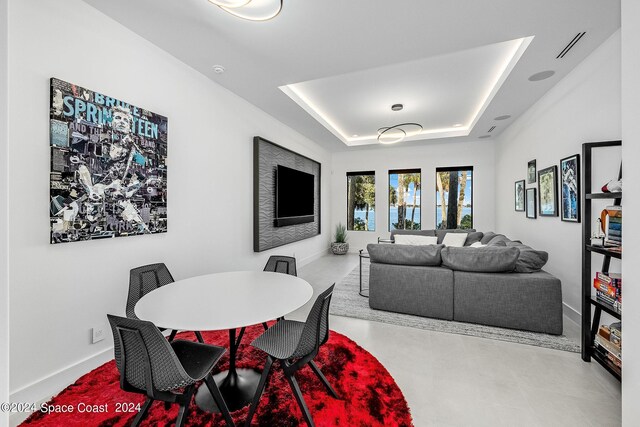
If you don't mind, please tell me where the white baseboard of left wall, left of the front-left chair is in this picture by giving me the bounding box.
[9,347,113,426]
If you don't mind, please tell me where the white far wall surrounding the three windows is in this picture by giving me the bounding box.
[331,141,495,252]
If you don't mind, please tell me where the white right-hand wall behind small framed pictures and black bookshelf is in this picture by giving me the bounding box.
[496,31,621,321]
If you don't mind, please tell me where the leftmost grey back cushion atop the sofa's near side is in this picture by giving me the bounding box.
[367,243,442,266]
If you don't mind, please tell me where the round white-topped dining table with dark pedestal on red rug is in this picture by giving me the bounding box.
[135,271,313,412]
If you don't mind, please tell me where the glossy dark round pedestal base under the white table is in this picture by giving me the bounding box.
[196,369,260,412]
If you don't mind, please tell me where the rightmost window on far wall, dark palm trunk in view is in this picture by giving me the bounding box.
[436,166,473,229]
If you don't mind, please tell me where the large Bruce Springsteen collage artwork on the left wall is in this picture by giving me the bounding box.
[49,78,167,243]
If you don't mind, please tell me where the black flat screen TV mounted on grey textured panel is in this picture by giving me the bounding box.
[275,165,315,227]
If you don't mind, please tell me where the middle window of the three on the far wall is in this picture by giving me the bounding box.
[389,169,422,231]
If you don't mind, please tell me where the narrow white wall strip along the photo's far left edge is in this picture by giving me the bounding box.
[0,0,9,426]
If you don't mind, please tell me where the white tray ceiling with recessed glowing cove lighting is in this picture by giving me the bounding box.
[84,0,620,151]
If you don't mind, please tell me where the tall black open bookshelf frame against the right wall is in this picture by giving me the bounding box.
[581,141,622,380]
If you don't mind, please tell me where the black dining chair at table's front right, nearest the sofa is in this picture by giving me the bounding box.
[245,283,339,427]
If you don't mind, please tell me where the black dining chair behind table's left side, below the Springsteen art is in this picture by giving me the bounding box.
[126,263,204,343]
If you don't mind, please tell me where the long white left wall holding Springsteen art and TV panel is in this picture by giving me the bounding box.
[6,0,330,408]
